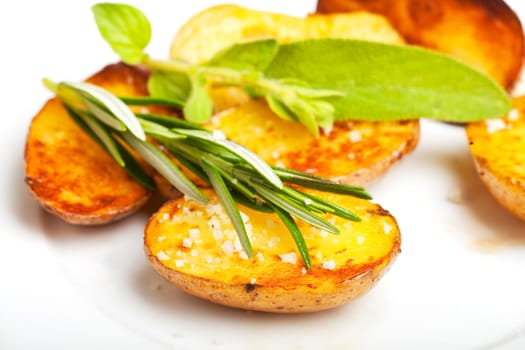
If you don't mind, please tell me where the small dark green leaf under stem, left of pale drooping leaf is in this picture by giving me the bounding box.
[148,70,191,106]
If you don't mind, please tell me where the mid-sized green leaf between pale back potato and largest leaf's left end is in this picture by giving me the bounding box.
[204,39,279,72]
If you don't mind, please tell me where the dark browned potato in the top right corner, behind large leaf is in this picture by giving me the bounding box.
[317,0,525,90]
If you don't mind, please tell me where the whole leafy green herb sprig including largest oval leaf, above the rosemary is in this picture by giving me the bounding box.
[93,3,511,135]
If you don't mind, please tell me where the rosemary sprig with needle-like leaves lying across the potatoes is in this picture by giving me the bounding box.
[46,81,370,268]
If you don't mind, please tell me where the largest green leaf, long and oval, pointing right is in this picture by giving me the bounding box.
[264,39,511,122]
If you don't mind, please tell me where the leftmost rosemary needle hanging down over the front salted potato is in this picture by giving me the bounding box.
[201,158,253,258]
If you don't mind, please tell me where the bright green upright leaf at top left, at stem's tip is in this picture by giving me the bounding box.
[92,3,151,64]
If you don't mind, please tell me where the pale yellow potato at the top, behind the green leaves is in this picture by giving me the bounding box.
[170,5,403,63]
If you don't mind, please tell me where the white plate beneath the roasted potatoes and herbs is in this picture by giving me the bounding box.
[0,0,525,350]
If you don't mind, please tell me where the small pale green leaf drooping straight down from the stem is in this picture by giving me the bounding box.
[183,75,213,124]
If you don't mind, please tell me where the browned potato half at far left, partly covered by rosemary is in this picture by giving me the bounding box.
[25,64,162,225]
